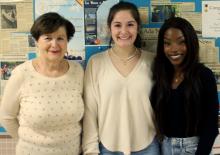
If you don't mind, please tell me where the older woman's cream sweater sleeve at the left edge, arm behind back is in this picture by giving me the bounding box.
[0,67,23,138]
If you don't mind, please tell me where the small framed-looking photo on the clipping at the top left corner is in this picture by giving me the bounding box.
[1,5,17,29]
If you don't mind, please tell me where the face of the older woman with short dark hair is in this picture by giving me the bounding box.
[36,26,68,61]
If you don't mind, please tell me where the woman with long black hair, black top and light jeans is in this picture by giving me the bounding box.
[151,17,218,155]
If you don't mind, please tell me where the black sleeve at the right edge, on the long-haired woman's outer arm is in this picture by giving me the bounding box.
[196,68,218,155]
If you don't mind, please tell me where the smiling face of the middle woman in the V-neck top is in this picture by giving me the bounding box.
[110,10,138,47]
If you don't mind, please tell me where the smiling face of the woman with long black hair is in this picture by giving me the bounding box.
[164,28,187,68]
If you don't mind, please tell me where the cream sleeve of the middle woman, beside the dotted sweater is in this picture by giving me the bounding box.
[82,60,99,155]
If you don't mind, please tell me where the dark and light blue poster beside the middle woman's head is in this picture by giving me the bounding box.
[84,0,119,45]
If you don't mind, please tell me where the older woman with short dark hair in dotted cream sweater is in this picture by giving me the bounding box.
[0,12,84,155]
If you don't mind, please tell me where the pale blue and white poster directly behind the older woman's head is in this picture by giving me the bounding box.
[34,0,85,60]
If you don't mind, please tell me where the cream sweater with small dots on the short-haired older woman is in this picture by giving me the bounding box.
[0,60,84,155]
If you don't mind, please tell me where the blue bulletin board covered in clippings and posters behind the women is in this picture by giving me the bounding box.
[0,0,220,152]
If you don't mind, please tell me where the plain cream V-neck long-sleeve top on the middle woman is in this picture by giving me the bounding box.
[83,51,155,154]
